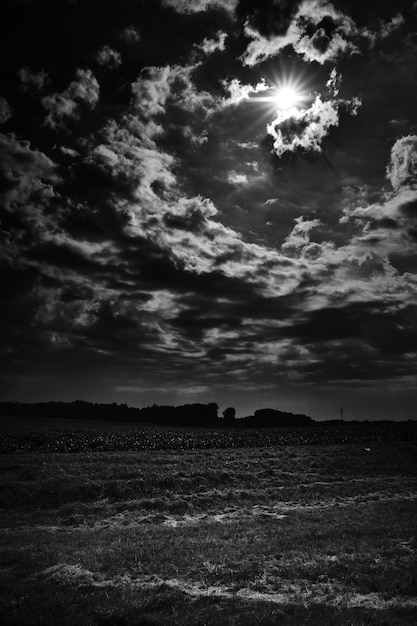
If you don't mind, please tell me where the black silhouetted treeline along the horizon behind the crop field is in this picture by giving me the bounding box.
[0,400,316,428]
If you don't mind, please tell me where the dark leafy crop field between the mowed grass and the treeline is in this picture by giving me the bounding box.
[0,417,417,454]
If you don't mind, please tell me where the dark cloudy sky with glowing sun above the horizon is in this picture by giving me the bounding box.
[0,0,417,419]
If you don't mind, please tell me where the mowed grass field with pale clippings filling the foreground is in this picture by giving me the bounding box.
[0,442,417,626]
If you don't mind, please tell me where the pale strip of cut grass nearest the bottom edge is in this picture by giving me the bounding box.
[31,563,417,610]
